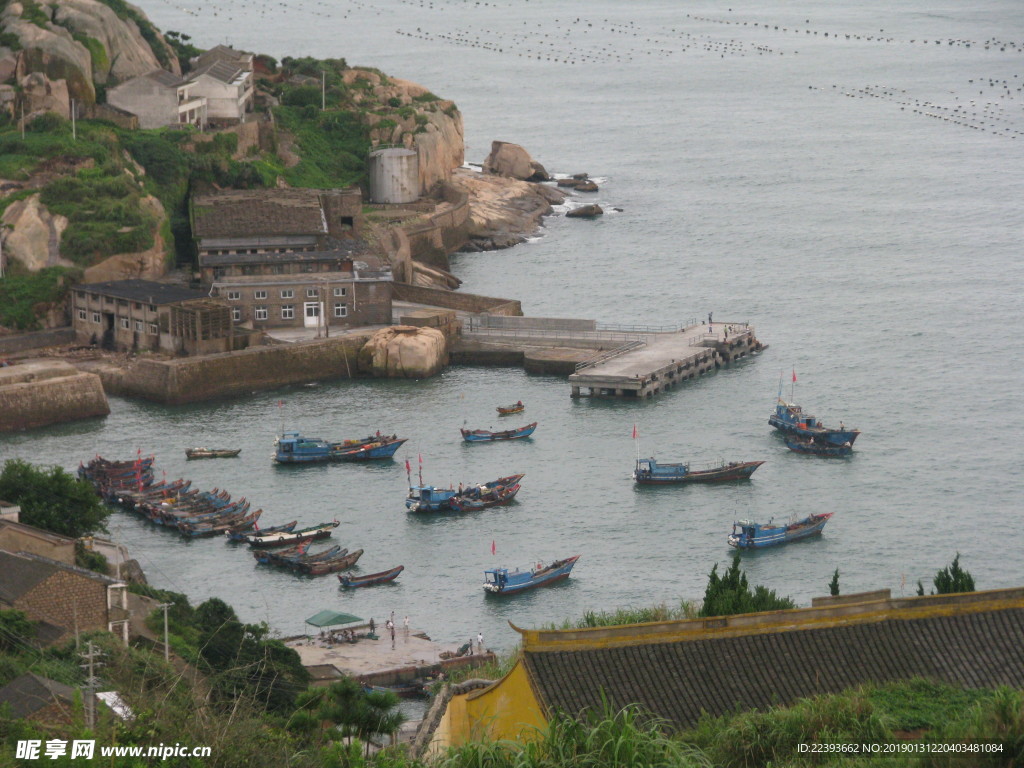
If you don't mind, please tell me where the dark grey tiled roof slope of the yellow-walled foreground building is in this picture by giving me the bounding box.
[522,607,1024,728]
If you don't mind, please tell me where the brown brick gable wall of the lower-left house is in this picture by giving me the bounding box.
[14,570,108,635]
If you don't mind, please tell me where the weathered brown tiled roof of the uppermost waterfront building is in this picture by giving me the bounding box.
[193,189,327,239]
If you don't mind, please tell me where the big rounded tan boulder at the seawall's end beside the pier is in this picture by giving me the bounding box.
[358,326,449,379]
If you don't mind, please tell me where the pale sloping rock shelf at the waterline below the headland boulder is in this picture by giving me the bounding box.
[452,169,566,251]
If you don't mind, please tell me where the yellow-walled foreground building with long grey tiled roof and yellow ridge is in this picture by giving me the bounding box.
[425,588,1024,750]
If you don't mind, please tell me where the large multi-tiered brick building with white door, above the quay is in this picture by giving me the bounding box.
[191,188,392,330]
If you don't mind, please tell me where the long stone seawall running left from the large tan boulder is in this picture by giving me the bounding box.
[117,333,371,404]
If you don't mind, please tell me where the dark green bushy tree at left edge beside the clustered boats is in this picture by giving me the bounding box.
[0,459,111,539]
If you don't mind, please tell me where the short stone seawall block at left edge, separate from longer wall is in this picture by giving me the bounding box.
[0,362,111,432]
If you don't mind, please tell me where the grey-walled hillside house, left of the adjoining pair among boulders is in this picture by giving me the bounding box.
[106,70,207,128]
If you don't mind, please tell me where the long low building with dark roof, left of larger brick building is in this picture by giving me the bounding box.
[71,279,237,354]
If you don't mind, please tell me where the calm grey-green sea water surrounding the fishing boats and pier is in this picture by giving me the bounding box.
[0,0,1024,649]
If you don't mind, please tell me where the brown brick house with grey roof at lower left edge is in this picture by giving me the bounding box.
[0,551,129,642]
